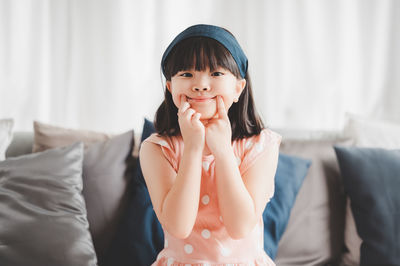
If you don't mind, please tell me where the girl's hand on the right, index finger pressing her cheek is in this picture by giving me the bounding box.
[206,96,232,156]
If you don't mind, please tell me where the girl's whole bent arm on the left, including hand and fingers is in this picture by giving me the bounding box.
[140,95,205,238]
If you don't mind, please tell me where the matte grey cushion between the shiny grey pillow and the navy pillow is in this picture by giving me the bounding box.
[83,130,136,265]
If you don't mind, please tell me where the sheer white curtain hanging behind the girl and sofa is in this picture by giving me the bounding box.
[0,0,400,133]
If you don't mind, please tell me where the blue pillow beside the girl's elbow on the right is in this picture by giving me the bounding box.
[263,153,311,260]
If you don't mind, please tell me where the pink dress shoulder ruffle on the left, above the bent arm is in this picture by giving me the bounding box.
[143,133,179,172]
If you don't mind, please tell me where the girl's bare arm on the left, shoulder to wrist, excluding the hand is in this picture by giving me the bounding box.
[139,142,202,239]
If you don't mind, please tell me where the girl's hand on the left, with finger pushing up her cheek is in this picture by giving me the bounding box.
[178,95,205,151]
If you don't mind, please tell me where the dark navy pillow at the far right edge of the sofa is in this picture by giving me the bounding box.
[335,146,400,265]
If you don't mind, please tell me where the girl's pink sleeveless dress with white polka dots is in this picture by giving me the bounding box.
[145,129,281,266]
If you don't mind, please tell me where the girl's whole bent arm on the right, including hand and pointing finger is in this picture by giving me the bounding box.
[206,97,279,239]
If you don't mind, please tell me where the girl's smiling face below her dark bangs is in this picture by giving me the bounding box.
[166,67,246,121]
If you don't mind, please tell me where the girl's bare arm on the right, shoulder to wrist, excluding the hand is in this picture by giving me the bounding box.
[215,145,279,239]
